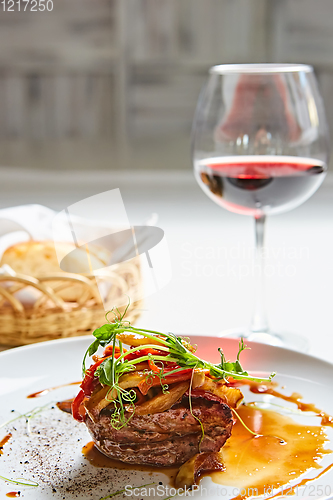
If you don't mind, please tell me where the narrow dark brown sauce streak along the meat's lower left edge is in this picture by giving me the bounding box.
[82,441,179,482]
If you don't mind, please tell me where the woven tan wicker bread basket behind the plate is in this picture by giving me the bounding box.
[0,257,141,347]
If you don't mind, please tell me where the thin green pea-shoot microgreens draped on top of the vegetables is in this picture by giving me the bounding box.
[82,304,275,429]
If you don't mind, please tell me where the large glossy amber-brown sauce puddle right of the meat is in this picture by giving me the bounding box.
[210,405,333,500]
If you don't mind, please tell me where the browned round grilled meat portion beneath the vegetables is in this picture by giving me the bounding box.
[85,396,233,466]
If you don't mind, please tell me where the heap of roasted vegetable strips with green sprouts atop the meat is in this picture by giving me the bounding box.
[73,311,274,428]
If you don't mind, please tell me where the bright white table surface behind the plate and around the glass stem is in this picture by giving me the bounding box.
[0,168,333,362]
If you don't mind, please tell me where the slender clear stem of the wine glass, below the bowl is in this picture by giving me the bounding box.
[250,215,269,333]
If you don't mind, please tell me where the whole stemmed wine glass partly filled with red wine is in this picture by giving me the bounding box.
[192,64,329,350]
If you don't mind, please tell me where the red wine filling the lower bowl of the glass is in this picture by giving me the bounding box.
[194,155,326,217]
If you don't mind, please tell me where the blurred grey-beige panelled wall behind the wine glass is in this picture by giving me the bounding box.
[0,0,333,170]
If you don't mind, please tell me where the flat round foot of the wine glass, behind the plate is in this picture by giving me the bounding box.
[218,328,309,352]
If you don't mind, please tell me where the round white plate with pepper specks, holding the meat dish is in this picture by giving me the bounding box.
[0,337,333,500]
